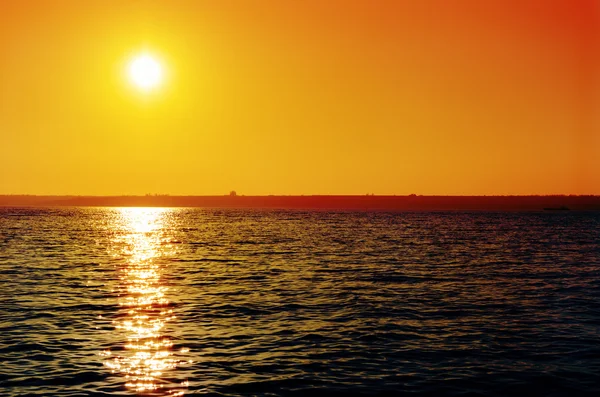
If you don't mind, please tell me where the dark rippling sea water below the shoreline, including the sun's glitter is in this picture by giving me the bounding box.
[0,208,600,396]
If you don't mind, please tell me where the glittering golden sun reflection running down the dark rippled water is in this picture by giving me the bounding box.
[101,208,188,396]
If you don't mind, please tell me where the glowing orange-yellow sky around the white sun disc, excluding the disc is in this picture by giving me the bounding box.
[0,0,600,195]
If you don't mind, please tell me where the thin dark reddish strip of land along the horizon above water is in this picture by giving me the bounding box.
[0,195,600,211]
